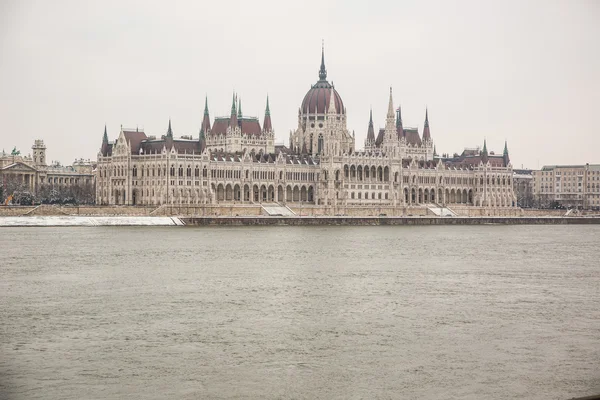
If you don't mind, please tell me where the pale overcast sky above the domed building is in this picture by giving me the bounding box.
[0,0,600,168]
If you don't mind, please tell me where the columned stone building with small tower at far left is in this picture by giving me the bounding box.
[0,140,95,204]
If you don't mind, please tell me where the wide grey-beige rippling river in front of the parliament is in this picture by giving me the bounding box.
[0,226,600,399]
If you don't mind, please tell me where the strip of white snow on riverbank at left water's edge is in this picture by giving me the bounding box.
[0,216,183,226]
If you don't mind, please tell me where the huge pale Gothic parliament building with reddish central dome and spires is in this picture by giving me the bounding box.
[96,47,516,212]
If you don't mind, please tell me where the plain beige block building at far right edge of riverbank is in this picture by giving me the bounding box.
[533,164,600,210]
